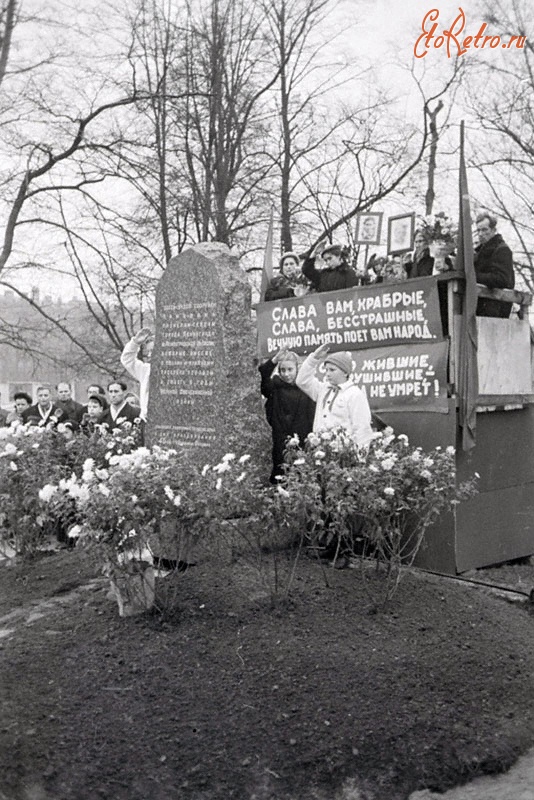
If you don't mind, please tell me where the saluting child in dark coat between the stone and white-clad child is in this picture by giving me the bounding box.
[259,350,315,483]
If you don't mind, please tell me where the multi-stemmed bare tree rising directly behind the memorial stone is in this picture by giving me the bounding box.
[181,0,292,244]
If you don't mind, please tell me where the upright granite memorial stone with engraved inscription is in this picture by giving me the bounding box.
[147,242,268,463]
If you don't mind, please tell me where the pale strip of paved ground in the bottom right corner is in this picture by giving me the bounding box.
[409,748,534,800]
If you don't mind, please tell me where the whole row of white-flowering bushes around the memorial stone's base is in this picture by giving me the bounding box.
[0,428,476,610]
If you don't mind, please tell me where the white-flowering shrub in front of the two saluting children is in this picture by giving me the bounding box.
[278,428,478,600]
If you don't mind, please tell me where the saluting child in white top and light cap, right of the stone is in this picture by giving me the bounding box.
[296,344,373,447]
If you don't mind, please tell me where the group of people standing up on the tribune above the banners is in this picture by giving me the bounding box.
[264,213,515,317]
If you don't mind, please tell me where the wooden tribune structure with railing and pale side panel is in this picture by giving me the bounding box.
[381,273,534,574]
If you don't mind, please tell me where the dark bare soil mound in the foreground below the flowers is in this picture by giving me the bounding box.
[0,551,534,800]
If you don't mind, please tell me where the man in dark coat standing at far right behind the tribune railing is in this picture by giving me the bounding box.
[475,214,515,318]
